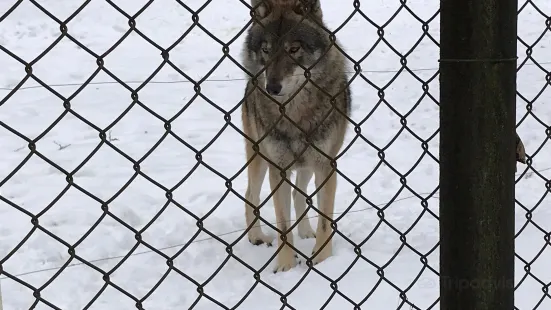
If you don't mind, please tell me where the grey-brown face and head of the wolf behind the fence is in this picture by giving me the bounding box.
[245,11,331,96]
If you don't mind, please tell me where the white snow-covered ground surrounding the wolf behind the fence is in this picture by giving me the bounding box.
[0,0,551,310]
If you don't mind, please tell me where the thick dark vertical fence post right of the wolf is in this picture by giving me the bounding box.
[440,0,517,310]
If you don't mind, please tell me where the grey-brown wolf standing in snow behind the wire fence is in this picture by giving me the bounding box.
[242,0,351,272]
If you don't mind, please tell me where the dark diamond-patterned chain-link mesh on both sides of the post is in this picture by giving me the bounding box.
[0,0,551,310]
